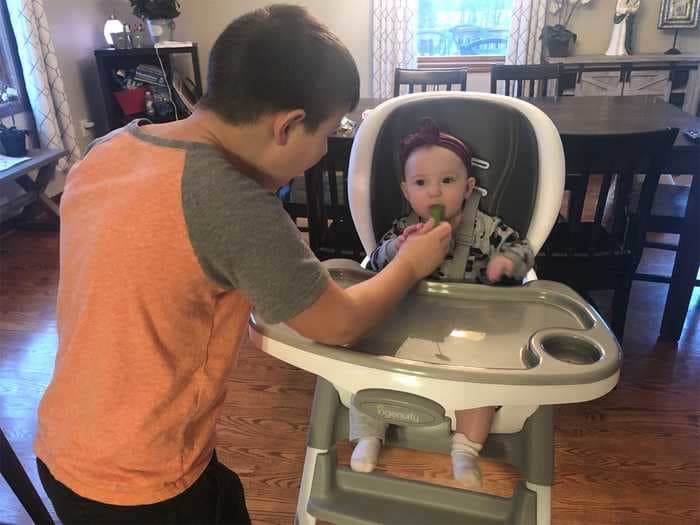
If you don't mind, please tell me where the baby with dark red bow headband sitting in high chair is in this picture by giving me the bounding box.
[350,118,534,488]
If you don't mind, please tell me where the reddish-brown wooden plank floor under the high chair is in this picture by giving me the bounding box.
[0,232,700,525]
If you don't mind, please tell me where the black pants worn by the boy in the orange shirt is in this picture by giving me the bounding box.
[36,453,250,525]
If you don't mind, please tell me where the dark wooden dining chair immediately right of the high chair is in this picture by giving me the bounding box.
[536,129,678,340]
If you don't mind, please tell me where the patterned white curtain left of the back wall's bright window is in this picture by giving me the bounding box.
[372,0,418,98]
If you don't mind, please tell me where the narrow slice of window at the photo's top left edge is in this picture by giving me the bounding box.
[0,0,27,117]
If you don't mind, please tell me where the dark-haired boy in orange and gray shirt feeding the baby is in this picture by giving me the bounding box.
[35,5,450,523]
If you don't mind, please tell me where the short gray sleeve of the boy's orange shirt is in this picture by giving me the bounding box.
[182,149,328,323]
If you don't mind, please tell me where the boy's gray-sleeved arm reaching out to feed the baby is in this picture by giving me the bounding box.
[182,156,450,344]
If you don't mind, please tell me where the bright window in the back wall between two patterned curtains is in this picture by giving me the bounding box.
[416,0,512,70]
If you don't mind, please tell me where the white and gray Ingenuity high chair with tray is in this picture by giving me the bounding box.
[250,92,621,525]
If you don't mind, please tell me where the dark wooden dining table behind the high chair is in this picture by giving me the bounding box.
[305,95,700,341]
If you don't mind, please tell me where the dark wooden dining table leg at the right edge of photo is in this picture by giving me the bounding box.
[659,173,700,341]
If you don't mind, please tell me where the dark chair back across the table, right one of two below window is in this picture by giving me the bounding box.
[491,64,562,97]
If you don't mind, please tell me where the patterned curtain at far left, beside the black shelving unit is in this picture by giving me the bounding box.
[7,0,80,173]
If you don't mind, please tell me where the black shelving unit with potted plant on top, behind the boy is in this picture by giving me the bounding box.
[95,43,202,132]
